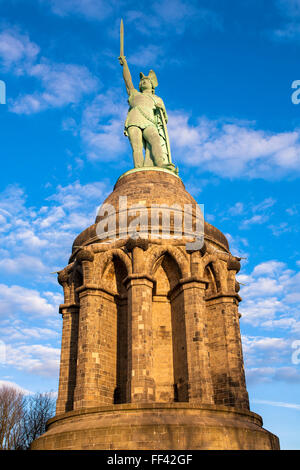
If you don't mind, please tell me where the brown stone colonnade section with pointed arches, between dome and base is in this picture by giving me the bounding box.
[58,240,249,412]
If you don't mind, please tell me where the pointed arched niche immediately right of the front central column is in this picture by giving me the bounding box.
[152,253,188,402]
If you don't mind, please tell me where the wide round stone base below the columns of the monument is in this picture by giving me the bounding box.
[31,403,279,450]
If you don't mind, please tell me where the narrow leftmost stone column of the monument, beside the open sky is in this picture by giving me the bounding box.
[56,304,79,414]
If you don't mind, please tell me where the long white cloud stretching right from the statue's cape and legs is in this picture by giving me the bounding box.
[168,112,300,178]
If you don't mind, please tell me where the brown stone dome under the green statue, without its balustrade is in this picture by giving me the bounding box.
[72,168,229,253]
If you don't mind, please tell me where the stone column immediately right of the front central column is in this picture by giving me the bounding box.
[170,277,214,404]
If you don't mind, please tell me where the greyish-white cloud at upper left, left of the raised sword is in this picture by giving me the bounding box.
[0,28,99,114]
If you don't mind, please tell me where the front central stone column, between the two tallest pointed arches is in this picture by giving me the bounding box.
[124,274,155,403]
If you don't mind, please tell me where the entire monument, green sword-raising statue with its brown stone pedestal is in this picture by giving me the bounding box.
[32,24,279,450]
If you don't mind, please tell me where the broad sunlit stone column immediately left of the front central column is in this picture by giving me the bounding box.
[74,285,117,409]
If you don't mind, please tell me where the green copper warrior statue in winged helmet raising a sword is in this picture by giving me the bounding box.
[119,20,178,173]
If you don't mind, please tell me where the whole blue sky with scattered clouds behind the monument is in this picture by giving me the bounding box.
[0,0,300,449]
